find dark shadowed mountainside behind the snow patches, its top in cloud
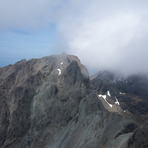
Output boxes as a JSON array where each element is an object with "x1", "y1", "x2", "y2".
[{"x1": 91, "y1": 71, "x2": 148, "y2": 123}]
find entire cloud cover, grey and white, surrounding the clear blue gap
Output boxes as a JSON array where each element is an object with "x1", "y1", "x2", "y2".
[{"x1": 0, "y1": 0, "x2": 148, "y2": 74}]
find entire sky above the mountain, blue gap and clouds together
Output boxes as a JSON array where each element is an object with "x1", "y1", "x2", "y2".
[{"x1": 0, "y1": 0, "x2": 148, "y2": 75}]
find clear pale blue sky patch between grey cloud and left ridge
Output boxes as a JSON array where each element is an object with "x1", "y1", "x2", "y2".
[{"x1": 0, "y1": 25, "x2": 62, "y2": 66}]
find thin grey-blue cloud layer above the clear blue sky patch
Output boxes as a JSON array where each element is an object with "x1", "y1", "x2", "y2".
[{"x1": 0, "y1": 0, "x2": 61, "y2": 31}]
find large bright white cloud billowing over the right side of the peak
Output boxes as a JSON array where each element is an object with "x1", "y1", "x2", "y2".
[{"x1": 56, "y1": 0, "x2": 148, "y2": 74}]
